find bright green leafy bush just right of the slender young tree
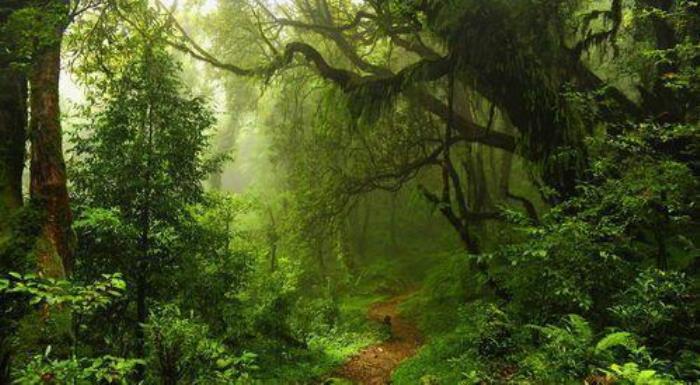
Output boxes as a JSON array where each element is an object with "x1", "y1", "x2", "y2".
[{"x1": 171, "y1": 193, "x2": 259, "y2": 340}]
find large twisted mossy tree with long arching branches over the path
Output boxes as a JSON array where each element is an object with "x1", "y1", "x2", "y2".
[{"x1": 138, "y1": 1, "x2": 592, "y2": 260}]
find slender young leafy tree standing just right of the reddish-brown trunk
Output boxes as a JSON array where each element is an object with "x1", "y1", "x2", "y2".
[{"x1": 74, "y1": 42, "x2": 217, "y2": 364}]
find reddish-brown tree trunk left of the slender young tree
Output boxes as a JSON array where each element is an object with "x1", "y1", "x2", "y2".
[{"x1": 29, "y1": 1, "x2": 74, "y2": 277}]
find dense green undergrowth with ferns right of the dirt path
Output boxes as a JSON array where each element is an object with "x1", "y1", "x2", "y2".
[{"x1": 394, "y1": 97, "x2": 697, "y2": 384}]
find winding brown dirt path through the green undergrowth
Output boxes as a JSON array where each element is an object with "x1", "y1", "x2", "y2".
[{"x1": 337, "y1": 293, "x2": 422, "y2": 385}]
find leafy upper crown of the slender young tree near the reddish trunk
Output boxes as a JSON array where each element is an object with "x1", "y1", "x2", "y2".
[{"x1": 74, "y1": 46, "x2": 216, "y2": 218}]
